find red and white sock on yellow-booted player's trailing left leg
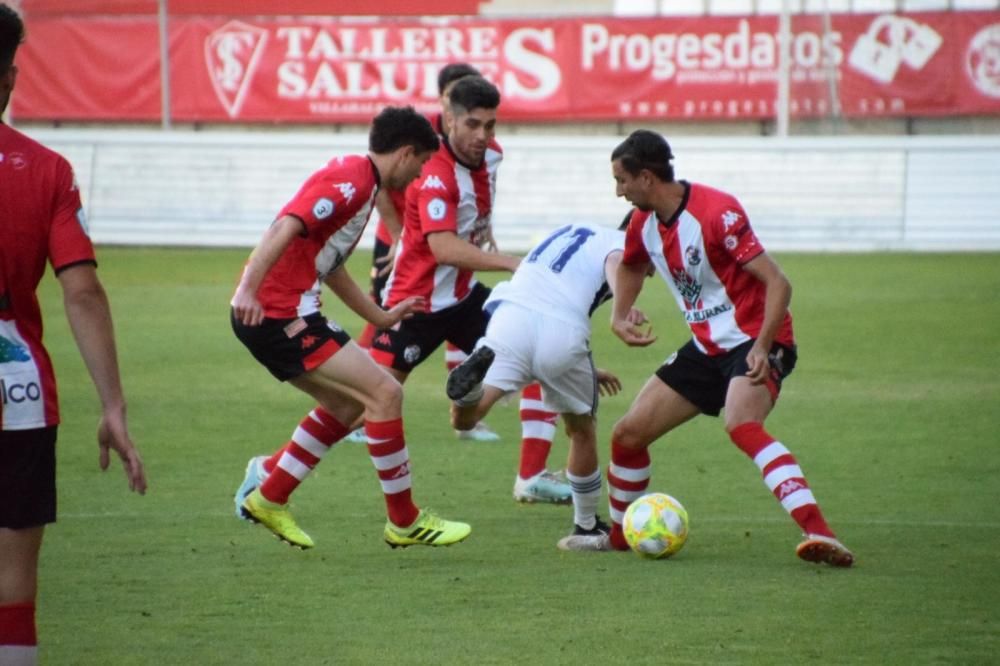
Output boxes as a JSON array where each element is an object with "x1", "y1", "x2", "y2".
[{"x1": 260, "y1": 406, "x2": 350, "y2": 504}]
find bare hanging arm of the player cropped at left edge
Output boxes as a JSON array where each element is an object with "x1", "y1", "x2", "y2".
[{"x1": 58, "y1": 264, "x2": 146, "y2": 494}]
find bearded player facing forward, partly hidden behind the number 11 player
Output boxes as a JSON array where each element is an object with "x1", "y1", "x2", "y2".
[{"x1": 372, "y1": 77, "x2": 571, "y2": 503}]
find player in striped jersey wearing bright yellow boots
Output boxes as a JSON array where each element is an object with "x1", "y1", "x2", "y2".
[{"x1": 231, "y1": 107, "x2": 470, "y2": 548}]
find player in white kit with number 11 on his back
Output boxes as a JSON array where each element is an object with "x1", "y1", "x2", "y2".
[{"x1": 447, "y1": 218, "x2": 645, "y2": 548}]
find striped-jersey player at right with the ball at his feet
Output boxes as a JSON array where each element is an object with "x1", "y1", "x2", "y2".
[{"x1": 572, "y1": 130, "x2": 854, "y2": 567}]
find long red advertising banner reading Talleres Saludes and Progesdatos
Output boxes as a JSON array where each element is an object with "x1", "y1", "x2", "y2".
[{"x1": 13, "y1": 11, "x2": 1000, "y2": 123}]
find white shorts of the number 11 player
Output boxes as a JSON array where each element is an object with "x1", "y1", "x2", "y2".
[{"x1": 479, "y1": 302, "x2": 598, "y2": 416}]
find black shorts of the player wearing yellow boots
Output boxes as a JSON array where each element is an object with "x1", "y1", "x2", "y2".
[{"x1": 229, "y1": 310, "x2": 351, "y2": 382}]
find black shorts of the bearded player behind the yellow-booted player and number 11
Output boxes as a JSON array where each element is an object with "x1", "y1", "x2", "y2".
[{"x1": 371, "y1": 283, "x2": 490, "y2": 372}]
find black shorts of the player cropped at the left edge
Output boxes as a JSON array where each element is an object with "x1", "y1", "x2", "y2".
[{"x1": 0, "y1": 426, "x2": 57, "y2": 530}]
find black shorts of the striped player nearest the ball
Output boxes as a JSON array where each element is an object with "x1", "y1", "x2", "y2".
[{"x1": 656, "y1": 340, "x2": 798, "y2": 416}]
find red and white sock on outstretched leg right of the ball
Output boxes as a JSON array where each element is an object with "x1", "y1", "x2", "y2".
[{"x1": 729, "y1": 421, "x2": 833, "y2": 538}]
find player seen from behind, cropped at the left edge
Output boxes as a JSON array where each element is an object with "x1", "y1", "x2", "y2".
[{"x1": 0, "y1": 4, "x2": 146, "y2": 664}]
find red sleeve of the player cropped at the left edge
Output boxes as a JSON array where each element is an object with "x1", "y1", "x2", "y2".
[{"x1": 49, "y1": 157, "x2": 94, "y2": 273}]
